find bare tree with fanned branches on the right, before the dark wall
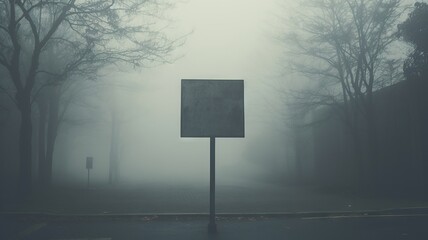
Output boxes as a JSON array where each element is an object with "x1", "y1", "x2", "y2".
[{"x1": 283, "y1": 0, "x2": 402, "y2": 183}]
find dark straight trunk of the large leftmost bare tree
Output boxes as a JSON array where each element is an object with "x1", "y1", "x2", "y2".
[{"x1": 18, "y1": 92, "x2": 32, "y2": 201}]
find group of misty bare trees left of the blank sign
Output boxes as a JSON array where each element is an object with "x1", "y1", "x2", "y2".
[{"x1": 0, "y1": 1, "x2": 181, "y2": 201}]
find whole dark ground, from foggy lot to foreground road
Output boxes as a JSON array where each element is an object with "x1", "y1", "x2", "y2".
[{"x1": 0, "y1": 183, "x2": 428, "y2": 240}]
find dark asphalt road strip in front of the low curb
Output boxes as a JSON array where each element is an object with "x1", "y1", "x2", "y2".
[{"x1": 0, "y1": 214, "x2": 428, "y2": 240}]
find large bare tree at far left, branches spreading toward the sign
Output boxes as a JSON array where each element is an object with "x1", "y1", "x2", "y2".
[{"x1": 0, "y1": 0, "x2": 182, "y2": 199}]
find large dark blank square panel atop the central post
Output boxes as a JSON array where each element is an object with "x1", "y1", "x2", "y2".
[{"x1": 181, "y1": 79, "x2": 245, "y2": 137}]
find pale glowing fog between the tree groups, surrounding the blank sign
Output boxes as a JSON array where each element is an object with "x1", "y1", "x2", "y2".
[{"x1": 53, "y1": 0, "x2": 287, "y2": 187}]
